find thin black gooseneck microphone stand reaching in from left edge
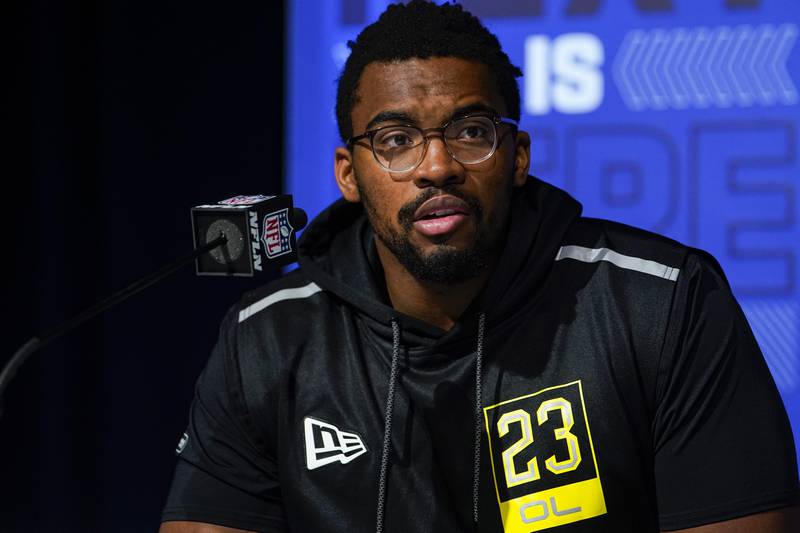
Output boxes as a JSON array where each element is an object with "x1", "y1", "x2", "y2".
[{"x1": 0, "y1": 233, "x2": 228, "y2": 419}]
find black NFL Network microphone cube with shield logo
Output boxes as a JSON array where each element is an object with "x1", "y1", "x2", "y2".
[{"x1": 192, "y1": 195, "x2": 297, "y2": 277}]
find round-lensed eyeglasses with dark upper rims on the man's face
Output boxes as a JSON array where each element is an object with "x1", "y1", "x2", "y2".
[{"x1": 347, "y1": 115, "x2": 517, "y2": 172}]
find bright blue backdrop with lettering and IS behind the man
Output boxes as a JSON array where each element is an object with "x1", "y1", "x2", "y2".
[{"x1": 285, "y1": 0, "x2": 800, "y2": 466}]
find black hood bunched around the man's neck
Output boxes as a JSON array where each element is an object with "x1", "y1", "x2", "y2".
[{"x1": 298, "y1": 177, "x2": 581, "y2": 346}]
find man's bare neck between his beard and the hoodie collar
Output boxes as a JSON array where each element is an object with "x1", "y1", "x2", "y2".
[{"x1": 376, "y1": 239, "x2": 492, "y2": 330}]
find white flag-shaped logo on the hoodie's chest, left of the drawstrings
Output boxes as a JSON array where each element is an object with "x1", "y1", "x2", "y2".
[{"x1": 303, "y1": 416, "x2": 367, "y2": 470}]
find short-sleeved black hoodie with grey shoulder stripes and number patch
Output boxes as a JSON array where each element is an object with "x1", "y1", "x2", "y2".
[{"x1": 163, "y1": 178, "x2": 797, "y2": 533}]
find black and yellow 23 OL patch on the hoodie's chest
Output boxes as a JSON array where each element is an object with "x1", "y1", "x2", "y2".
[{"x1": 483, "y1": 381, "x2": 606, "y2": 533}]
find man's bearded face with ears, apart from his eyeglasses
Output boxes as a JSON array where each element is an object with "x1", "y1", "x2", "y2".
[{"x1": 336, "y1": 57, "x2": 529, "y2": 284}]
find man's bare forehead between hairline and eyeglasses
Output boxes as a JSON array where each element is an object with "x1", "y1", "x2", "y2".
[{"x1": 352, "y1": 57, "x2": 505, "y2": 128}]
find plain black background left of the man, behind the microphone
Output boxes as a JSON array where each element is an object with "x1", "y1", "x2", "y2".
[{"x1": 0, "y1": 0, "x2": 284, "y2": 533}]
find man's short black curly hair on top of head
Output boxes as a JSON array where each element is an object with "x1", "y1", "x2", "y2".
[{"x1": 336, "y1": 0, "x2": 522, "y2": 141}]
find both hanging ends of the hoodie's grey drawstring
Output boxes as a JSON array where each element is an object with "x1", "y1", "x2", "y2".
[{"x1": 375, "y1": 313, "x2": 486, "y2": 533}]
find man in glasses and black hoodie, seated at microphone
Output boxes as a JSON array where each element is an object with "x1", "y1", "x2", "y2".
[{"x1": 162, "y1": 1, "x2": 798, "y2": 533}]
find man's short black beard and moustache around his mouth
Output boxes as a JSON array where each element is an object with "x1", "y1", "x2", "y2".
[{"x1": 358, "y1": 185, "x2": 501, "y2": 285}]
